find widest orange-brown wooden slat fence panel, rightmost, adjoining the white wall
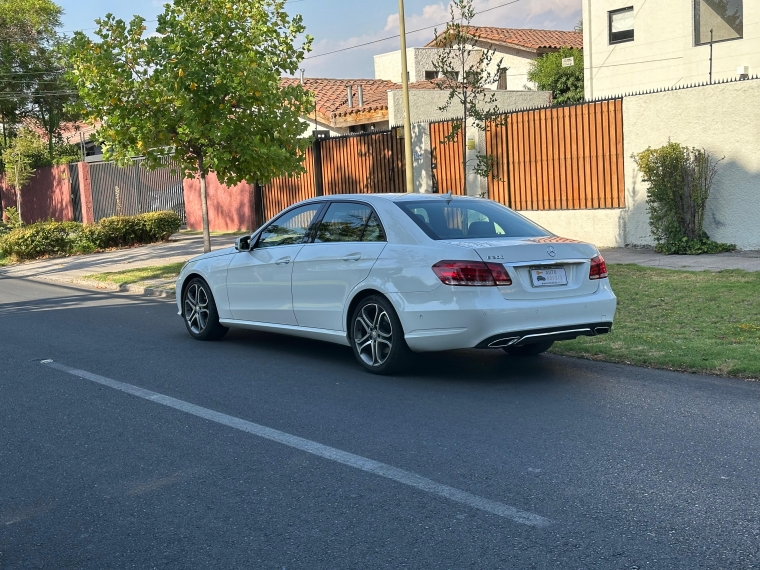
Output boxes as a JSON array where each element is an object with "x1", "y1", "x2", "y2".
[{"x1": 486, "y1": 99, "x2": 625, "y2": 210}]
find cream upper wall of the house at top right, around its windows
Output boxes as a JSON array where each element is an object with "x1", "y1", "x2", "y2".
[{"x1": 582, "y1": 0, "x2": 760, "y2": 99}]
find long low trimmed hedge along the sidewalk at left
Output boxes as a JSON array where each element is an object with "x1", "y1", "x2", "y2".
[{"x1": 0, "y1": 211, "x2": 182, "y2": 260}]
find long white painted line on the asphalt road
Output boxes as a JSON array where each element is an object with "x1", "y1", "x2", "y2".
[{"x1": 41, "y1": 360, "x2": 552, "y2": 527}]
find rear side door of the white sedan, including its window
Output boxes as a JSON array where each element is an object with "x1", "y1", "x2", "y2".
[{"x1": 293, "y1": 201, "x2": 386, "y2": 331}]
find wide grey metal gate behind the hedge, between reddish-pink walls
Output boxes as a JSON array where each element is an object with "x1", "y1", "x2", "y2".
[{"x1": 90, "y1": 158, "x2": 185, "y2": 225}]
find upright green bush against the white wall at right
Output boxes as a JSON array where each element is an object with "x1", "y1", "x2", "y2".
[{"x1": 633, "y1": 142, "x2": 736, "y2": 255}]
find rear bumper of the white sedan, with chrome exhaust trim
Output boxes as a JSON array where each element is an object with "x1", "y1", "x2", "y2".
[{"x1": 388, "y1": 279, "x2": 617, "y2": 352}]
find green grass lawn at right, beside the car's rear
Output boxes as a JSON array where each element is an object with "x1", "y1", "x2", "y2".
[{"x1": 552, "y1": 265, "x2": 760, "y2": 379}]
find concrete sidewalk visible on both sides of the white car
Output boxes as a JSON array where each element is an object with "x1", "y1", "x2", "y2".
[{"x1": 0, "y1": 234, "x2": 760, "y2": 297}]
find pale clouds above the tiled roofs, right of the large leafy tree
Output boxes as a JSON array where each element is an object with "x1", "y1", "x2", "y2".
[{"x1": 304, "y1": 0, "x2": 581, "y2": 78}]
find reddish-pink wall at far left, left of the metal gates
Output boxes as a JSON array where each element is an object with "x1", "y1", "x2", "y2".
[{"x1": 0, "y1": 165, "x2": 74, "y2": 224}]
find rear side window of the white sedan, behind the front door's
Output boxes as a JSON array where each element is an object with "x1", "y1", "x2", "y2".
[{"x1": 314, "y1": 202, "x2": 385, "y2": 243}]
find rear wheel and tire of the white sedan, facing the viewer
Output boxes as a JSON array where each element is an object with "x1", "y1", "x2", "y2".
[{"x1": 349, "y1": 295, "x2": 411, "y2": 374}]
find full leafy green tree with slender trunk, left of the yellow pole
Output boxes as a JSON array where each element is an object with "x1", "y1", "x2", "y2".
[{"x1": 71, "y1": 0, "x2": 312, "y2": 251}]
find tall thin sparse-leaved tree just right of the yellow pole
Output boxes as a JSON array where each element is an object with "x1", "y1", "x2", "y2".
[{"x1": 433, "y1": 0, "x2": 506, "y2": 195}]
